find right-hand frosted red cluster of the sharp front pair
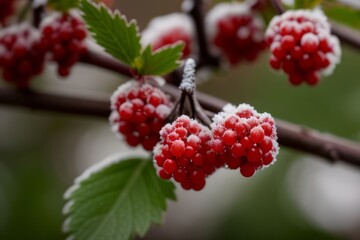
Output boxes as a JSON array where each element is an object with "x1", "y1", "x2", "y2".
[{"x1": 211, "y1": 104, "x2": 278, "y2": 177}]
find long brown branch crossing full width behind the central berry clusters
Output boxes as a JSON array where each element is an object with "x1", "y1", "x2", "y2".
[{"x1": 0, "y1": 85, "x2": 360, "y2": 167}]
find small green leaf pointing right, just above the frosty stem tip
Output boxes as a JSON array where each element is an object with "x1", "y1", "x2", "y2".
[{"x1": 137, "y1": 43, "x2": 184, "y2": 75}]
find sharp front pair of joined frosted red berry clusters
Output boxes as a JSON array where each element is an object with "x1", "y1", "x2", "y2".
[{"x1": 154, "y1": 104, "x2": 279, "y2": 191}]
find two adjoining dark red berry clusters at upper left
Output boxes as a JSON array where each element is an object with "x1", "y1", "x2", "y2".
[{"x1": 0, "y1": 11, "x2": 87, "y2": 87}]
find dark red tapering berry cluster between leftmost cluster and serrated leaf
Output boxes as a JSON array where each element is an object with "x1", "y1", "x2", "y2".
[{"x1": 41, "y1": 14, "x2": 87, "y2": 77}]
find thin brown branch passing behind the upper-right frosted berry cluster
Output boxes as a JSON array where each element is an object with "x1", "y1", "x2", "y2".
[{"x1": 271, "y1": 0, "x2": 360, "y2": 50}]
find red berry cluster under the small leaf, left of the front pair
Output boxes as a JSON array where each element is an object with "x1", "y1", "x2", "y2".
[{"x1": 110, "y1": 81, "x2": 172, "y2": 151}]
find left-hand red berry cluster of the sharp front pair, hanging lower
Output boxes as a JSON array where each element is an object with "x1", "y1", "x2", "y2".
[{"x1": 154, "y1": 115, "x2": 217, "y2": 191}]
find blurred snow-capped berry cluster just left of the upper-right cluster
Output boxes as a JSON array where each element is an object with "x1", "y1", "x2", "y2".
[{"x1": 206, "y1": 2, "x2": 266, "y2": 65}]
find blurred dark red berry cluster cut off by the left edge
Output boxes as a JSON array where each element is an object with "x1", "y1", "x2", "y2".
[{"x1": 0, "y1": 24, "x2": 45, "y2": 87}]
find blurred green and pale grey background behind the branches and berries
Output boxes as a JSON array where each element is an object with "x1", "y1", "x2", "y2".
[{"x1": 0, "y1": 0, "x2": 360, "y2": 240}]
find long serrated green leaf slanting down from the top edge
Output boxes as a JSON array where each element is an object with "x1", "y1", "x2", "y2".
[{"x1": 80, "y1": 0, "x2": 141, "y2": 68}]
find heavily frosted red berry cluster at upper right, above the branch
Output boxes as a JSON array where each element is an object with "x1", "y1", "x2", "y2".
[{"x1": 266, "y1": 10, "x2": 341, "y2": 85}]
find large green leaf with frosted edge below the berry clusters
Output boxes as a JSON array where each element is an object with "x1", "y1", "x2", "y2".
[{"x1": 64, "y1": 156, "x2": 176, "y2": 240}]
